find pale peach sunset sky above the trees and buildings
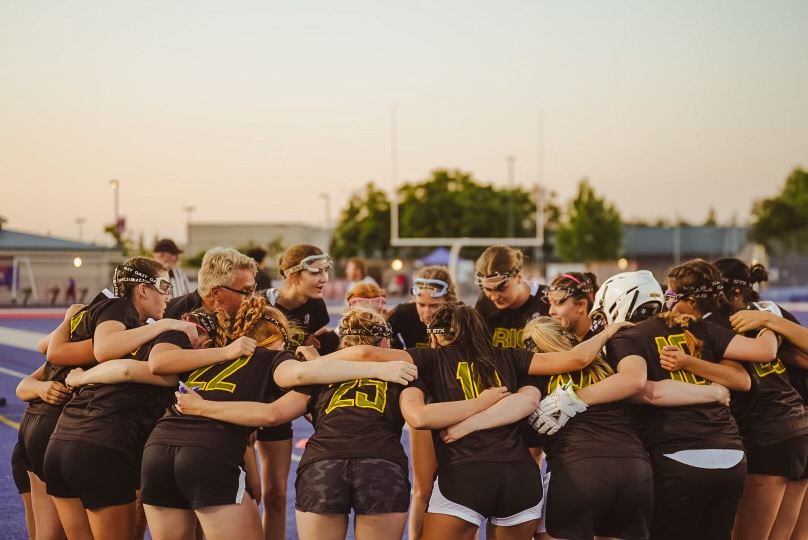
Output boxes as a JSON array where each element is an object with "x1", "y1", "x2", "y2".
[{"x1": 0, "y1": 0, "x2": 808, "y2": 243}]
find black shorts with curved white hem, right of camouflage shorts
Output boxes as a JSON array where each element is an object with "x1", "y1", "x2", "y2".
[{"x1": 427, "y1": 462, "x2": 543, "y2": 527}]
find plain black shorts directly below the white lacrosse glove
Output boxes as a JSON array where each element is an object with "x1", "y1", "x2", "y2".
[{"x1": 546, "y1": 457, "x2": 654, "y2": 540}]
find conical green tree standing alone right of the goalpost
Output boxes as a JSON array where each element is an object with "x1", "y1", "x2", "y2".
[{"x1": 556, "y1": 178, "x2": 623, "y2": 262}]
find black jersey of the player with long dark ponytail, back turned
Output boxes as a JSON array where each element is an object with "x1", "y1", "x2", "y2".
[{"x1": 407, "y1": 346, "x2": 536, "y2": 473}]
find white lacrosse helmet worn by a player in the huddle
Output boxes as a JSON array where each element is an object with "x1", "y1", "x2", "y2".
[{"x1": 589, "y1": 270, "x2": 665, "y2": 324}]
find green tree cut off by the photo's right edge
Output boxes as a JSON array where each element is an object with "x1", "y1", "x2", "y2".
[{"x1": 749, "y1": 168, "x2": 808, "y2": 253}]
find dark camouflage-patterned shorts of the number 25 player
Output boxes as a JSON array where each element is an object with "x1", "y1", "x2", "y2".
[{"x1": 295, "y1": 458, "x2": 410, "y2": 516}]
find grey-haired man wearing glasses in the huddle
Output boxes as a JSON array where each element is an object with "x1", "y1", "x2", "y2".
[{"x1": 165, "y1": 247, "x2": 258, "y2": 319}]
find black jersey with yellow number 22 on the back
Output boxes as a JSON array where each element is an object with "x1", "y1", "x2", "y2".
[{"x1": 146, "y1": 348, "x2": 295, "y2": 463}]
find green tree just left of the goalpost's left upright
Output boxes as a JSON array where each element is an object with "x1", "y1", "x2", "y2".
[{"x1": 329, "y1": 182, "x2": 390, "y2": 259}]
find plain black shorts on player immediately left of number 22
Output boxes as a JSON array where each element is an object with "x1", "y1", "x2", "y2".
[{"x1": 45, "y1": 439, "x2": 138, "y2": 510}]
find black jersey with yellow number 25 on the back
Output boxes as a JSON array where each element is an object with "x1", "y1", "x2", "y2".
[{"x1": 295, "y1": 379, "x2": 407, "y2": 469}]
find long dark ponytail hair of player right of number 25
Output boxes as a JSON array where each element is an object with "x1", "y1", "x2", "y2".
[{"x1": 429, "y1": 302, "x2": 501, "y2": 391}]
